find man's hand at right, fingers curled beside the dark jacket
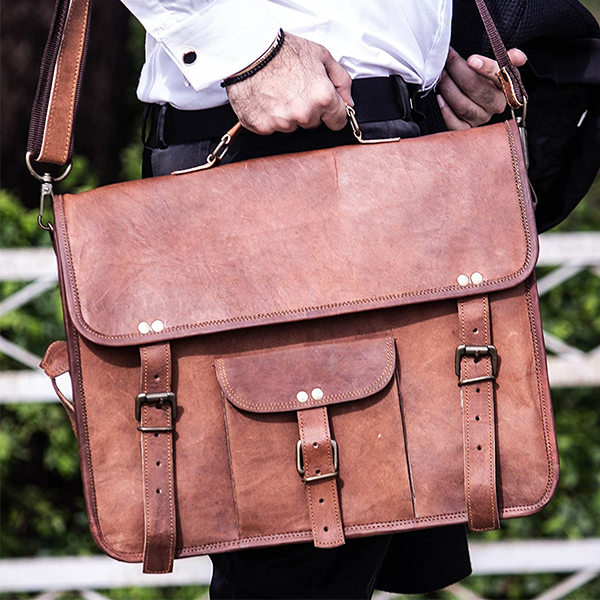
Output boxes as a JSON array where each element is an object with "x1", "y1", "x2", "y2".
[{"x1": 437, "y1": 48, "x2": 527, "y2": 130}]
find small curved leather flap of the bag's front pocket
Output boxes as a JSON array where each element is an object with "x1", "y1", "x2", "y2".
[{"x1": 215, "y1": 337, "x2": 396, "y2": 413}]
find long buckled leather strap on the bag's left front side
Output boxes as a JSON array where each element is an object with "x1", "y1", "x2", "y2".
[{"x1": 136, "y1": 342, "x2": 176, "y2": 573}]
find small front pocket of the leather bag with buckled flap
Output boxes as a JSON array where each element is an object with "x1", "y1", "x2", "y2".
[{"x1": 215, "y1": 337, "x2": 414, "y2": 547}]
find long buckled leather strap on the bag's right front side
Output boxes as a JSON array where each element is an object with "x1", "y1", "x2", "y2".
[{"x1": 457, "y1": 296, "x2": 500, "y2": 531}]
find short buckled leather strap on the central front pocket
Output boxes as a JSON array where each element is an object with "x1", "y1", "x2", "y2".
[{"x1": 297, "y1": 406, "x2": 345, "y2": 548}]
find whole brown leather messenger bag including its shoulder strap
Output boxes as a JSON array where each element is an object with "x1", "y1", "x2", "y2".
[{"x1": 28, "y1": 0, "x2": 558, "y2": 573}]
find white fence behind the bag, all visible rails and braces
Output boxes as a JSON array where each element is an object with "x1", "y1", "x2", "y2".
[{"x1": 0, "y1": 232, "x2": 600, "y2": 600}]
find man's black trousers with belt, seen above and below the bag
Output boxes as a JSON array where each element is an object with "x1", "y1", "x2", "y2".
[{"x1": 143, "y1": 77, "x2": 471, "y2": 600}]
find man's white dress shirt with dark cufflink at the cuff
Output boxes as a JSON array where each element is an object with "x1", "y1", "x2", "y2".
[{"x1": 122, "y1": 0, "x2": 452, "y2": 110}]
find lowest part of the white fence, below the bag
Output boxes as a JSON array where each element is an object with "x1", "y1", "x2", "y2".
[{"x1": 0, "y1": 539, "x2": 600, "y2": 600}]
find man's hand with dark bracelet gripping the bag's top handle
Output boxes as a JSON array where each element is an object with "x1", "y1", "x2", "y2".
[{"x1": 227, "y1": 33, "x2": 354, "y2": 135}]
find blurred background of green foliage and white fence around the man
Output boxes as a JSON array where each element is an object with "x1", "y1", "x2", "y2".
[{"x1": 0, "y1": 0, "x2": 600, "y2": 600}]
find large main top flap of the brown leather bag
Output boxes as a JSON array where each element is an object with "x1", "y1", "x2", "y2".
[{"x1": 55, "y1": 122, "x2": 538, "y2": 346}]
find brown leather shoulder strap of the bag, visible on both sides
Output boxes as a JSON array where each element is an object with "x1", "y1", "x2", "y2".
[{"x1": 27, "y1": 0, "x2": 527, "y2": 165}]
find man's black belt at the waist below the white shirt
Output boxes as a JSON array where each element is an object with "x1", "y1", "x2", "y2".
[{"x1": 144, "y1": 75, "x2": 443, "y2": 147}]
